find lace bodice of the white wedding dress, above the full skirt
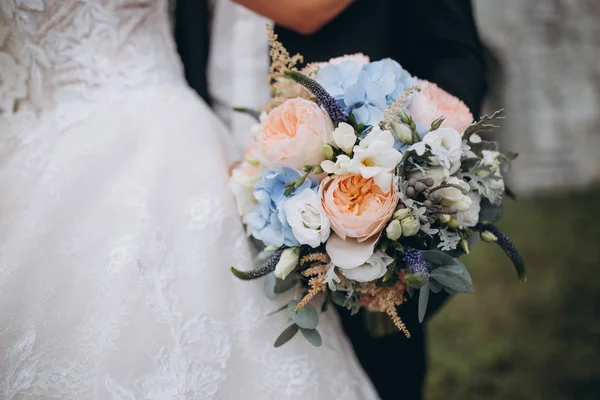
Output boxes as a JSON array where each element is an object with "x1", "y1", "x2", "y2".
[{"x1": 0, "y1": 0, "x2": 182, "y2": 116}]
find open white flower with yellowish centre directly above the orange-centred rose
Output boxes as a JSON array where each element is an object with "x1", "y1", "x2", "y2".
[{"x1": 350, "y1": 126, "x2": 402, "y2": 193}]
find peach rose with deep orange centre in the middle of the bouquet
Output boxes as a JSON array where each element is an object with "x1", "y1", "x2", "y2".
[{"x1": 319, "y1": 175, "x2": 398, "y2": 242}]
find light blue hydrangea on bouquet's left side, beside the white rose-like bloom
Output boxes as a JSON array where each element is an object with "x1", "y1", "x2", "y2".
[{"x1": 245, "y1": 168, "x2": 312, "y2": 247}]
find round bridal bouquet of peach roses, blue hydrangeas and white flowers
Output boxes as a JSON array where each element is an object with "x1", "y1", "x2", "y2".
[{"x1": 230, "y1": 30, "x2": 525, "y2": 346}]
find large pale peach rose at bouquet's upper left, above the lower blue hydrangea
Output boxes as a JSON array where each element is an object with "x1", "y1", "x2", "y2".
[{"x1": 254, "y1": 98, "x2": 333, "y2": 170}]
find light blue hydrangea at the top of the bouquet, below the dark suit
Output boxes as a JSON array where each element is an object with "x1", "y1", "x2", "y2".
[{"x1": 316, "y1": 59, "x2": 417, "y2": 125}]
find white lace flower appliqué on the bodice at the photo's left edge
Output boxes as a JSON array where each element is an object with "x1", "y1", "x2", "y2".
[{"x1": 0, "y1": 51, "x2": 27, "y2": 115}]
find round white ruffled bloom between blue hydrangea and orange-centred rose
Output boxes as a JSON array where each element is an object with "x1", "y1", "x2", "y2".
[{"x1": 283, "y1": 189, "x2": 331, "y2": 248}]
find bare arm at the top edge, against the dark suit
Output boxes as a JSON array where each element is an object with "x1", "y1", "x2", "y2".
[{"x1": 233, "y1": 0, "x2": 354, "y2": 35}]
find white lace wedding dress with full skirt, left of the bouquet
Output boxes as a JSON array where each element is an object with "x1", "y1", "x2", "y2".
[{"x1": 0, "y1": 0, "x2": 376, "y2": 400}]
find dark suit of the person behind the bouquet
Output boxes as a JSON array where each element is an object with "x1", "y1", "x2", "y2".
[{"x1": 177, "y1": 0, "x2": 487, "y2": 400}]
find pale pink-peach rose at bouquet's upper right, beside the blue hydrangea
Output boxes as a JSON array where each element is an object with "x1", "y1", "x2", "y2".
[{"x1": 408, "y1": 79, "x2": 473, "y2": 134}]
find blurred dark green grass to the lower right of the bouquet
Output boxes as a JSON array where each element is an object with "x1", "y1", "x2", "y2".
[{"x1": 426, "y1": 189, "x2": 600, "y2": 400}]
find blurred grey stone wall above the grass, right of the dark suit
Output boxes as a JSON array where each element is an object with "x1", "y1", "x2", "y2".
[{"x1": 474, "y1": 0, "x2": 600, "y2": 193}]
